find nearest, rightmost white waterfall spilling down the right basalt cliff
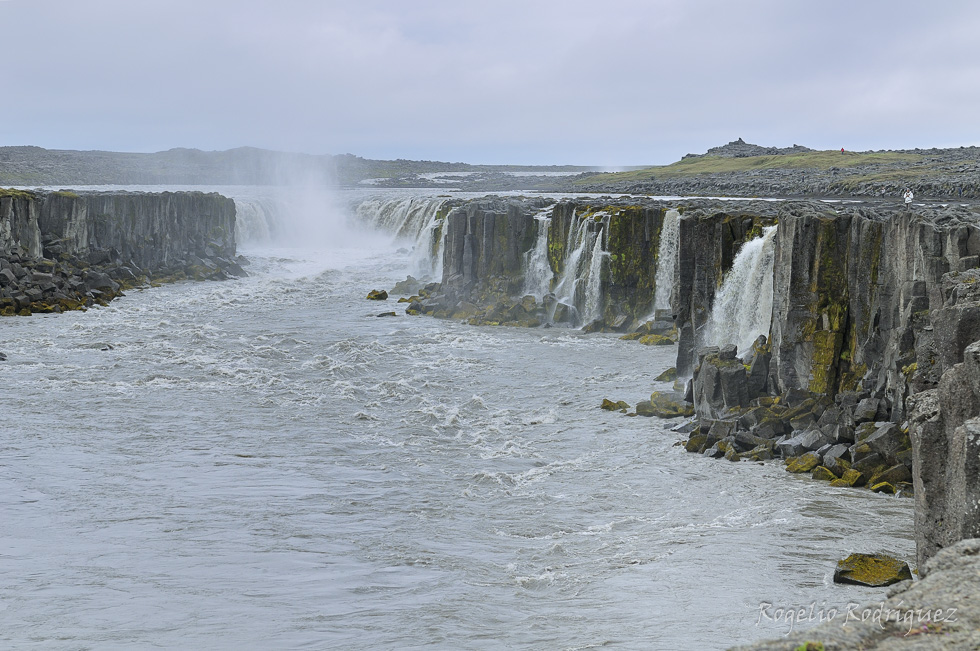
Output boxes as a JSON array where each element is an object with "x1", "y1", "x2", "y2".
[{"x1": 707, "y1": 226, "x2": 776, "y2": 356}]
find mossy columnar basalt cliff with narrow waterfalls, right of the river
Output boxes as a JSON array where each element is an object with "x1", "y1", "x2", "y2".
[{"x1": 394, "y1": 198, "x2": 980, "y2": 562}]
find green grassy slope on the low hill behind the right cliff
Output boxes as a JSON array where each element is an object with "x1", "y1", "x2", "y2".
[{"x1": 578, "y1": 150, "x2": 922, "y2": 184}]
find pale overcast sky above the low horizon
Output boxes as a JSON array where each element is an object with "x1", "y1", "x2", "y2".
[{"x1": 0, "y1": 0, "x2": 980, "y2": 166}]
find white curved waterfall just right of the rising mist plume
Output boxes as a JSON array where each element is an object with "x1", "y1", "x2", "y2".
[{"x1": 354, "y1": 197, "x2": 447, "y2": 280}]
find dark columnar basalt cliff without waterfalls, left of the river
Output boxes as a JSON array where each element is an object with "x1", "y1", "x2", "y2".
[{"x1": 0, "y1": 190, "x2": 244, "y2": 315}]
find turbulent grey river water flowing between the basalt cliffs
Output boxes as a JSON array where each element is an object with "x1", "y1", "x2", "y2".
[{"x1": 0, "y1": 186, "x2": 913, "y2": 649}]
